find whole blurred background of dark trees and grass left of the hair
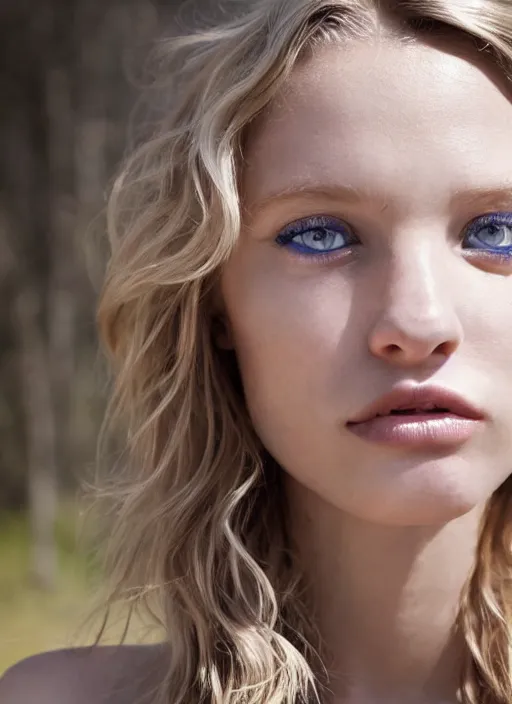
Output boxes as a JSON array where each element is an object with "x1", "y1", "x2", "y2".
[{"x1": 0, "y1": 0, "x2": 214, "y2": 674}]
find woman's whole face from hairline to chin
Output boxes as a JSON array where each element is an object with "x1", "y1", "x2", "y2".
[{"x1": 222, "y1": 35, "x2": 512, "y2": 525}]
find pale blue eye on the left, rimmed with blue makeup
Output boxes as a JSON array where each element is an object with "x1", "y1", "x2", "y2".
[{"x1": 276, "y1": 215, "x2": 358, "y2": 255}]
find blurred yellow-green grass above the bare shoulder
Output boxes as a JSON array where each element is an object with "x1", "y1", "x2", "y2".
[{"x1": 0, "y1": 504, "x2": 162, "y2": 675}]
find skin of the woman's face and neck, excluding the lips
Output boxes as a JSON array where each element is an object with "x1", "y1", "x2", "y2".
[{"x1": 222, "y1": 31, "x2": 512, "y2": 704}]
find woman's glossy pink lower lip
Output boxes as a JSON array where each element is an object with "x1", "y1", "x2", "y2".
[{"x1": 346, "y1": 413, "x2": 481, "y2": 447}]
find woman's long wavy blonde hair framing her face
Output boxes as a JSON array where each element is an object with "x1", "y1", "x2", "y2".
[{"x1": 91, "y1": 0, "x2": 512, "y2": 704}]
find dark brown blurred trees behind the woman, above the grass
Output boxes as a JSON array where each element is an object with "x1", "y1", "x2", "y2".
[{"x1": 0, "y1": 0, "x2": 171, "y2": 588}]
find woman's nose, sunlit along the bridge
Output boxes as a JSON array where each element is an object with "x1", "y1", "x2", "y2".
[{"x1": 368, "y1": 246, "x2": 462, "y2": 367}]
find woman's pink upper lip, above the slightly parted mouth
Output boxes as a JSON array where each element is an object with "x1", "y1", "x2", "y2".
[{"x1": 348, "y1": 386, "x2": 484, "y2": 423}]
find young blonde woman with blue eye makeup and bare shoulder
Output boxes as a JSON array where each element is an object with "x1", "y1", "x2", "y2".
[{"x1": 0, "y1": 0, "x2": 512, "y2": 704}]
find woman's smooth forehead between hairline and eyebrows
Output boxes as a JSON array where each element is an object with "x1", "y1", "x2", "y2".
[{"x1": 243, "y1": 42, "x2": 512, "y2": 212}]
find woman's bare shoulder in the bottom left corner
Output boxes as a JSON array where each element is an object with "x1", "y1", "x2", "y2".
[{"x1": 0, "y1": 644, "x2": 167, "y2": 704}]
